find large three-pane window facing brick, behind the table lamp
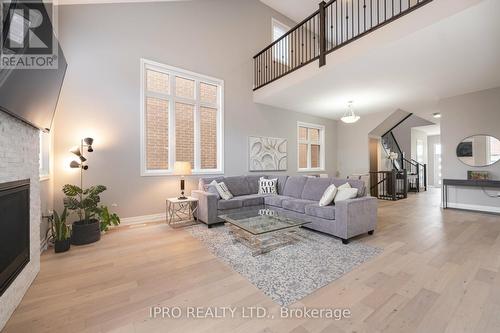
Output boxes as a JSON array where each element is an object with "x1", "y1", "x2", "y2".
[{"x1": 141, "y1": 59, "x2": 224, "y2": 176}]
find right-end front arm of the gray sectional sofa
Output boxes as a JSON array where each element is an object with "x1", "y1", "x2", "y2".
[{"x1": 335, "y1": 196, "x2": 378, "y2": 239}]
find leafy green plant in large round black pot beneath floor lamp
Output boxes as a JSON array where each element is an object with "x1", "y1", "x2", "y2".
[{"x1": 63, "y1": 184, "x2": 106, "y2": 245}]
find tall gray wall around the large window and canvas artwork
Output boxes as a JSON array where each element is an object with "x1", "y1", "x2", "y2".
[{"x1": 54, "y1": 0, "x2": 337, "y2": 217}]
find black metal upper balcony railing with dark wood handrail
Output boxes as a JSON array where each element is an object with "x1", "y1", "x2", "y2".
[{"x1": 254, "y1": 0, "x2": 432, "y2": 90}]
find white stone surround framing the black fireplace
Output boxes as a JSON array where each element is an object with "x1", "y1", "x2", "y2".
[{"x1": 0, "y1": 111, "x2": 41, "y2": 330}]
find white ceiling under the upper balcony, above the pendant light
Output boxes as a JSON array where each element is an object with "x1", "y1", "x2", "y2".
[{"x1": 254, "y1": 0, "x2": 500, "y2": 120}]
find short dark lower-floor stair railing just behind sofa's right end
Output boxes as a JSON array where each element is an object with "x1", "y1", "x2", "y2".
[{"x1": 370, "y1": 170, "x2": 408, "y2": 201}]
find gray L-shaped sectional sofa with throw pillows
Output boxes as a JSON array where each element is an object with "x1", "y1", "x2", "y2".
[{"x1": 191, "y1": 175, "x2": 377, "y2": 243}]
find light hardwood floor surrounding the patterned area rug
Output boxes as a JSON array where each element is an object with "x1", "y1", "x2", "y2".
[{"x1": 5, "y1": 189, "x2": 500, "y2": 333}]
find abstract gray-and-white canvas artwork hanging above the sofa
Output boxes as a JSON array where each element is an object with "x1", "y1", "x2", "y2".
[{"x1": 248, "y1": 136, "x2": 287, "y2": 171}]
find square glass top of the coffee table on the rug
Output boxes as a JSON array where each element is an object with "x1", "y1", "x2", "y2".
[{"x1": 219, "y1": 206, "x2": 310, "y2": 235}]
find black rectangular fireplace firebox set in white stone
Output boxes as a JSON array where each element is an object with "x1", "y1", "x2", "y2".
[{"x1": 0, "y1": 179, "x2": 30, "y2": 296}]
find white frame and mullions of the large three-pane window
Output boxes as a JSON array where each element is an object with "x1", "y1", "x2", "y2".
[{"x1": 140, "y1": 59, "x2": 224, "y2": 176}]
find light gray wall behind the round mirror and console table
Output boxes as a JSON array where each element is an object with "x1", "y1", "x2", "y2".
[{"x1": 439, "y1": 88, "x2": 500, "y2": 212}]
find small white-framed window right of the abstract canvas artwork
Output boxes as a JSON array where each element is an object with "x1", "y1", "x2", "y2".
[{"x1": 297, "y1": 122, "x2": 325, "y2": 171}]
